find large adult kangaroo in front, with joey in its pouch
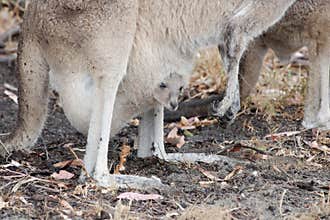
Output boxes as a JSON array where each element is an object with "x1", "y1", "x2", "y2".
[{"x1": 1, "y1": 0, "x2": 295, "y2": 188}]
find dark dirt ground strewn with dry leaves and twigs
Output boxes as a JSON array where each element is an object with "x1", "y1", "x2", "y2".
[{"x1": 0, "y1": 55, "x2": 330, "y2": 219}]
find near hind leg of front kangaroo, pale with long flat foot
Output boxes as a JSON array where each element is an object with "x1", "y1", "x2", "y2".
[{"x1": 79, "y1": 1, "x2": 163, "y2": 188}]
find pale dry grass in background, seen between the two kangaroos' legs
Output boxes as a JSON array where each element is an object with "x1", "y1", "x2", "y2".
[{"x1": 190, "y1": 48, "x2": 308, "y2": 120}]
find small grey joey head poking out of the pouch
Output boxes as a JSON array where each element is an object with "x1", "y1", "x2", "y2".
[{"x1": 153, "y1": 73, "x2": 186, "y2": 111}]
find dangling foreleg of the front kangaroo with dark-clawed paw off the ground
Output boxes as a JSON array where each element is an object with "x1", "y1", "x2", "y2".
[{"x1": 213, "y1": 0, "x2": 295, "y2": 122}]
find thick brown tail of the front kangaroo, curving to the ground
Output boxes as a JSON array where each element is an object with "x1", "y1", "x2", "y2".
[{"x1": 0, "y1": 36, "x2": 49, "y2": 156}]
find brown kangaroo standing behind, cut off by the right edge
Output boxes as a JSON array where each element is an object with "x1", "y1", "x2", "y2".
[{"x1": 240, "y1": 0, "x2": 330, "y2": 129}]
